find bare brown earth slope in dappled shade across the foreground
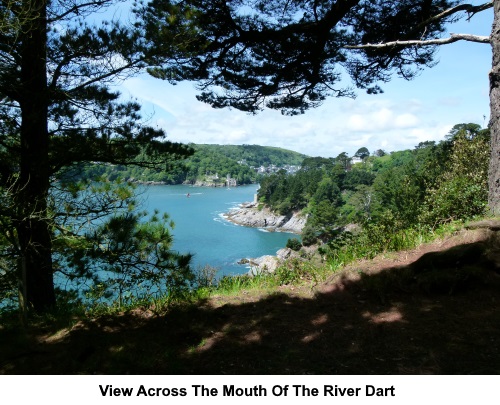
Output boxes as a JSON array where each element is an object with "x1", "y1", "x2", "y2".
[{"x1": 0, "y1": 223, "x2": 500, "y2": 374}]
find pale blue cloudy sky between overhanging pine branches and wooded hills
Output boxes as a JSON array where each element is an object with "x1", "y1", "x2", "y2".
[{"x1": 120, "y1": 1, "x2": 493, "y2": 157}]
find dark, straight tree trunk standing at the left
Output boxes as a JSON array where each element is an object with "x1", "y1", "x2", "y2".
[{"x1": 16, "y1": 0, "x2": 55, "y2": 311}]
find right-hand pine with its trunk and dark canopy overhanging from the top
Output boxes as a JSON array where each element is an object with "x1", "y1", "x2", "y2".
[{"x1": 144, "y1": 0, "x2": 500, "y2": 213}]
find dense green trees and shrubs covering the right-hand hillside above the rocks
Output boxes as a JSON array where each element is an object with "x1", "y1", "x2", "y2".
[{"x1": 254, "y1": 124, "x2": 489, "y2": 261}]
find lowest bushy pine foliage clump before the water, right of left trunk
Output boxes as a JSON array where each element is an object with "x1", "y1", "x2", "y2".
[{"x1": 82, "y1": 213, "x2": 194, "y2": 302}]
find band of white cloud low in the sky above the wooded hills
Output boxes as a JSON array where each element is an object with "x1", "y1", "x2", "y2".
[{"x1": 123, "y1": 49, "x2": 488, "y2": 156}]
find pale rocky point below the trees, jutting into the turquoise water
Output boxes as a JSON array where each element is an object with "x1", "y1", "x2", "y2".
[{"x1": 225, "y1": 203, "x2": 307, "y2": 233}]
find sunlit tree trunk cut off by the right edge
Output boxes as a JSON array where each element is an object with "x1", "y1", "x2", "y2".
[{"x1": 488, "y1": 0, "x2": 500, "y2": 215}]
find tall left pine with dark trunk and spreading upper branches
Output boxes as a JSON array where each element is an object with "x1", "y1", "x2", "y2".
[{"x1": 0, "y1": 0, "x2": 191, "y2": 310}]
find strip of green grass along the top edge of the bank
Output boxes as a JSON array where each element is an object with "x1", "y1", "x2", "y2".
[{"x1": 0, "y1": 222, "x2": 463, "y2": 326}]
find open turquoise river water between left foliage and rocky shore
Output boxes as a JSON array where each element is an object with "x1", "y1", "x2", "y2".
[{"x1": 139, "y1": 185, "x2": 297, "y2": 275}]
